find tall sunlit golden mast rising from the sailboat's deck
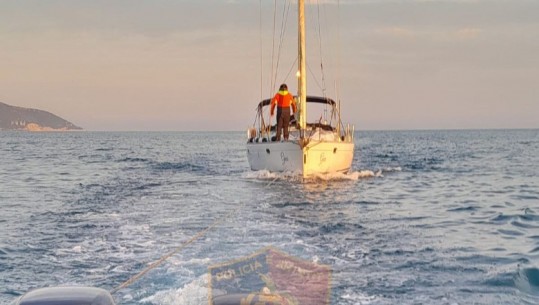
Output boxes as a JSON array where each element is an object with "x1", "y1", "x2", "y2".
[{"x1": 298, "y1": 0, "x2": 307, "y2": 140}]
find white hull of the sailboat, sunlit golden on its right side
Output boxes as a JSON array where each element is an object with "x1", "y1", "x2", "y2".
[{"x1": 247, "y1": 139, "x2": 354, "y2": 177}]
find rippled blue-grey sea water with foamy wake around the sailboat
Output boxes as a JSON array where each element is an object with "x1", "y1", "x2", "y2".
[{"x1": 0, "y1": 130, "x2": 539, "y2": 305}]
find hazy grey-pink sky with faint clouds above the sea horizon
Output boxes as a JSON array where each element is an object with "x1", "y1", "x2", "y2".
[{"x1": 0, "y1": 0, "x2": 539, "y2": 131}]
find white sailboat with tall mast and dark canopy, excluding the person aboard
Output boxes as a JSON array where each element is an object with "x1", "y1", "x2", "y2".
[{"x1": 247, "y1": 0, "x2": 354, "y2": 178}]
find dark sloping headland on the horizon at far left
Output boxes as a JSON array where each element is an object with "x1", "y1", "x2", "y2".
[{"x1": 0, "y1": 102, "x2": 82, "y2": 131}]
